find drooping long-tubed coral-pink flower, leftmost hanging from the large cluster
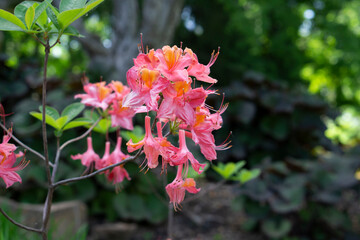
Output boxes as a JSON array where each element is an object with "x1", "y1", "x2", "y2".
[{"x1": 126, "y1": 116, "x2": 160, "y2": 168}]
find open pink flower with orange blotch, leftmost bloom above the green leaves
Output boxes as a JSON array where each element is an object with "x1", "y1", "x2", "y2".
[{"x1": 75, "y1": 82, "x2": 112, "y2": 110}]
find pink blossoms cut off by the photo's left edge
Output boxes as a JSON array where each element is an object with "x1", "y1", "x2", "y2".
[{"x1": 0, "y1": 130, "x2": 28, "y2": 188}]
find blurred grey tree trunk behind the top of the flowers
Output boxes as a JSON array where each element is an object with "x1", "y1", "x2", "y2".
[{"x1": 76, "y1": 0, "x2": 184, "y2": 82}]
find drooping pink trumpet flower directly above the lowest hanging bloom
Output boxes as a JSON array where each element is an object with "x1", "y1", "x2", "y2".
[{"x1": 171, "y1": 130, "x2": 206, "y2": 174}]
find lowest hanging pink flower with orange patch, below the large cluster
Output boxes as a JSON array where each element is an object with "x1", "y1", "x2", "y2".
[{"x1": 166, "y1": 165, "x2": 201, "y2": 210}]
